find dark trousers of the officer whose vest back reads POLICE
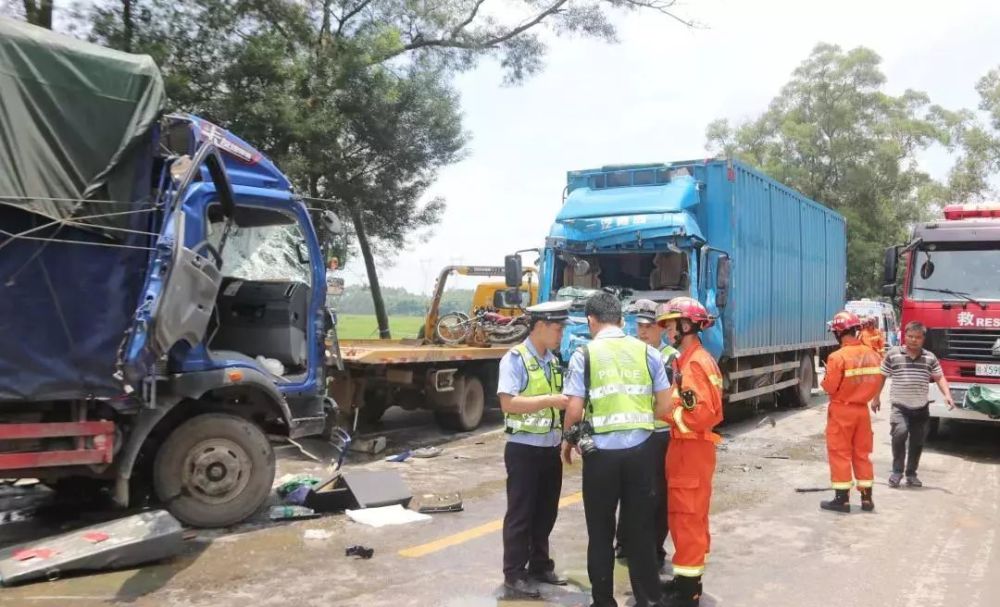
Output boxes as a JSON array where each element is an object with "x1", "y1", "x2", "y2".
[{"x1": 583, "y1": 439, "x2": 662, "y2": 607}]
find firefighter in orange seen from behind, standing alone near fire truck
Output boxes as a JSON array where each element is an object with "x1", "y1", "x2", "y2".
[{"x1": 820, "y1": 312, "x2": 882, "y2": 512}]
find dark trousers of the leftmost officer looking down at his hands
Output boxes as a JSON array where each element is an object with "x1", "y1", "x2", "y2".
[{"x1": 503, "y1": 442, "x2": 562, "y2": 580}]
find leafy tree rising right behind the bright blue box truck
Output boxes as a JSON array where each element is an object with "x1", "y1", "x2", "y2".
[{"x1": 706, "y1": 44, "x2": 956, "y2": 298}]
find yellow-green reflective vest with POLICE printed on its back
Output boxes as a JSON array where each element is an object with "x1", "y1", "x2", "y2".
[{"x1": 584, "y1": 337, "x2": 655, "y2": 434}]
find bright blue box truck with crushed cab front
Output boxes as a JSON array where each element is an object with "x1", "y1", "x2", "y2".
[{"x1": 540, "y1": 159, "x2": 847, "y2": 405}]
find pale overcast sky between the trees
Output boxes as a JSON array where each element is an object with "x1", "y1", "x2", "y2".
[{"x1": 343, "y1": 0, "x2": 1000, "y2": 292}]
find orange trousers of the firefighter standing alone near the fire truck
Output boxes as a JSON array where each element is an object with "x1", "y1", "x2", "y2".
[{"x1": 826, "y1": 402, "x2": 875, "y2": 489}]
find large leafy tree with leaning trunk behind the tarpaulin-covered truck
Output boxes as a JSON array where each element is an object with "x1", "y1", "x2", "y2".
[{"x1": 81, "y1": 0, "x2": 688, "y2": 337}]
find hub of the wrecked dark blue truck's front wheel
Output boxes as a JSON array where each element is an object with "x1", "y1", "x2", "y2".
[{"x1": 184, "y1": 438, "x2": 252, "y2": 503}]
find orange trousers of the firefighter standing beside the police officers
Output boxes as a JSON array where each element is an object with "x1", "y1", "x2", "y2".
[{"x1": 667, "y1": 434, "x2": 715, "y2": 577}]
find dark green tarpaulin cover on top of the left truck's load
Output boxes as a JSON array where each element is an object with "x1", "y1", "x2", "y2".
[{"x1": 0, "y1": 18, "x2": 165, "y2": 236}]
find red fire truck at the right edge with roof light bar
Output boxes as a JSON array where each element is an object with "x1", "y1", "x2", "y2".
[{"x1": 884, "y1": 204, "x2": 1000, "y2": 433}]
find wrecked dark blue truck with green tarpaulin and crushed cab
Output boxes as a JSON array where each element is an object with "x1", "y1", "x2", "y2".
[{"x1": 0, "y1": 19, "x2": 339, "y2": 527}]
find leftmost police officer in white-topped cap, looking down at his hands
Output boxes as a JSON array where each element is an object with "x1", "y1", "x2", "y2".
[{"x1": 497, "y1": 302, "x2": 570, "y2": 598}]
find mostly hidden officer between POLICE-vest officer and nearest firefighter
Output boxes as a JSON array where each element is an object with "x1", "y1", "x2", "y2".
[{"x1": 615, "y1": 299, "x2": 677, "y2": 576}]
